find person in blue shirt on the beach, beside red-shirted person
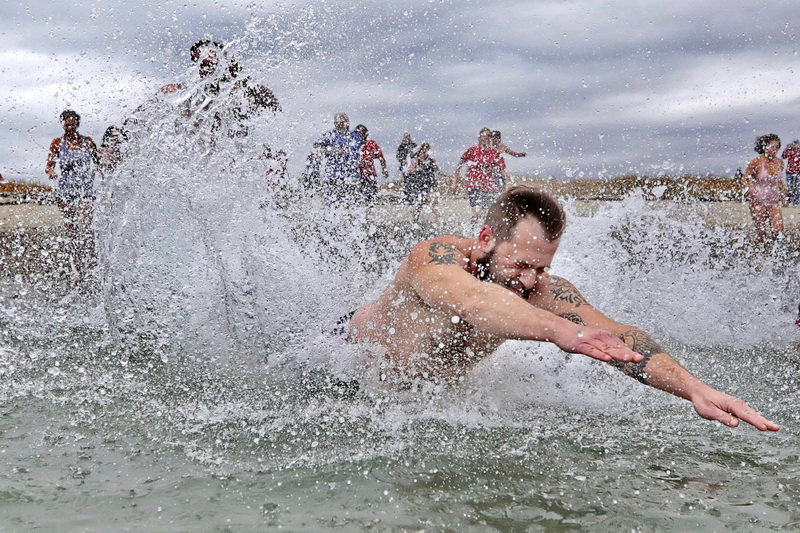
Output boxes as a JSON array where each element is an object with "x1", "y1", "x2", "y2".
[{"x1": 314, "y1": 113, "x2": 364, "y2": 205}]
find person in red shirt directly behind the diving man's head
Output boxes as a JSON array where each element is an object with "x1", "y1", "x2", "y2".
[{"x1": 452, "y1": 128, "x2": 508, "y2": 220}]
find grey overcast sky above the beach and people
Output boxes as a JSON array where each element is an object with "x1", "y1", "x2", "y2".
[{"x1": 0, "y1": 0, "x2": 800, "y2": 180}]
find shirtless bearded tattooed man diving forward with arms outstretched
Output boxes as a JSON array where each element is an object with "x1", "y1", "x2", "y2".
[{"x1": 349, "y1": 186, "x2": 779, "y2": 431}]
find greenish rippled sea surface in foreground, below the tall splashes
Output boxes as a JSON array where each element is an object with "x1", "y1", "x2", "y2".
[{"x1": 0, "y1": 285, "x2": 800, "y2": 531}]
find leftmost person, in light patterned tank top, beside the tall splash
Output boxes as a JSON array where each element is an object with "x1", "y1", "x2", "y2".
[{"x1": 45, "y1": 109, "x2": 99, "y2": 281}]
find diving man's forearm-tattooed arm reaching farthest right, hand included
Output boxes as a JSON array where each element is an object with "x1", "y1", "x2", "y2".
[{"x1": 541, "y1": 277, "x2": 780, "y2": 431}]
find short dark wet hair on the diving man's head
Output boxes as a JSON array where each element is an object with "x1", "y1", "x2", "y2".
[{"x1": 486, "y1": 185, "x2": 567, "y2": 241}]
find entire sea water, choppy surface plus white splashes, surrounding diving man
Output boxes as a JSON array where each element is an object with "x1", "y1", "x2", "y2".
[{"x1": 0, "y1": 52, "x2": 800, "y2": 531}]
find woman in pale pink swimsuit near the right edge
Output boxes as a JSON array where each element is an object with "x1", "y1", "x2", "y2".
[{"x1": 742, "y1": 133, "x2": 786, "y2": 250}]
